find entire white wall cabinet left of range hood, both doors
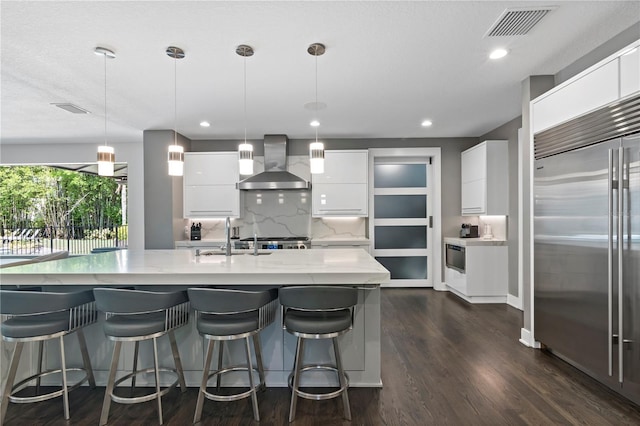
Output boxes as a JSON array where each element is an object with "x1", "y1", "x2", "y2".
[{"x1": 183, "y1": 152, "x2": 241, "y2": 218}]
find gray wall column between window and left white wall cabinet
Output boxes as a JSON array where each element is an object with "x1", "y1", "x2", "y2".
[{"x1": 142, "y1": 130, "x2": 190, "y2": 249}]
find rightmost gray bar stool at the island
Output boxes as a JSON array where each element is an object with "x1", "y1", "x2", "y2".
[{"x1": 280, "y1": 286, "x2": 358, "y2": 422}]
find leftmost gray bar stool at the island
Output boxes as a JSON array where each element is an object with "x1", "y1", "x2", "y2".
[{"x1": 0, "y1": 289, "x2": 98, "y2": 424}]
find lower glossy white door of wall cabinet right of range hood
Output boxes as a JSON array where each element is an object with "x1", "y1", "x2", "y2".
[{"x1": 312, "y1": 183, "x2": 368, "y2": 217}]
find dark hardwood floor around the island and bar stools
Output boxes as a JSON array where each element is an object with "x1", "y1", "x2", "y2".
[{"x1": 5, "y1": 289, "x2": 640, "y2": 426}]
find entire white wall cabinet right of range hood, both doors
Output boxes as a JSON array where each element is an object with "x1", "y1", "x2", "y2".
[{"x1": 311, "y1": 150, "x2": 369, "y2": 217}]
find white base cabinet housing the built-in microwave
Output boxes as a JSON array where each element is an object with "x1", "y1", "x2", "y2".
[{"x1": 445, "y1": 238, "x2": 509, "y2": 303}]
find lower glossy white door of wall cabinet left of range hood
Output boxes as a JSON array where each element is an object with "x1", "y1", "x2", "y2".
[{"x1": 184, "y1": 185, "x2": 240, "y2": 218}]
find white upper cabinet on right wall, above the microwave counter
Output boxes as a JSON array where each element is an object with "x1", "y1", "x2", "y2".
[{"x1": 461, "y1": 140, "x2": 509, "y2": 216}]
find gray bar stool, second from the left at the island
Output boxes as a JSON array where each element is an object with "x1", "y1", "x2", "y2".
[{"x1": 93, "y1": 288, "x2": 189, "y2": 425}]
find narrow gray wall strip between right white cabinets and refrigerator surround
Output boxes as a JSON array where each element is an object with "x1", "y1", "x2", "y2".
[{"x1": 480, "y1": 116, "x2": 522, "y2": 297}]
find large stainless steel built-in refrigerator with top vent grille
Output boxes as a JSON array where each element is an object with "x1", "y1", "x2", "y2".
[{"x1": 533, "y1": 96, "x2": 640, "y2": 404}]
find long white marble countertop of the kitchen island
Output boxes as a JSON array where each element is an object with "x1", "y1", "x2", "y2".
[{"x1": 0, "y1": 248, "x2": 390, "y2": 285}]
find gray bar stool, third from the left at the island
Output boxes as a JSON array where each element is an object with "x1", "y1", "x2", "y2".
[{"x1": 189, "y1": 288, "x2": 278, "y2": 423}]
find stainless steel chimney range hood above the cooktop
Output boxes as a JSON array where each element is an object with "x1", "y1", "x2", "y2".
[{"x1": 236, "y1": 135, "x2": 311, "y2": 191}]
